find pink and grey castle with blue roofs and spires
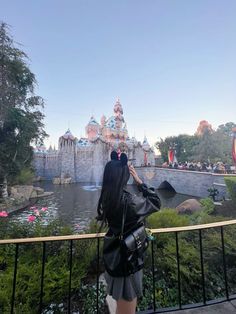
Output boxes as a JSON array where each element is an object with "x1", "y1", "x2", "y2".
[{"x1": 34, "y1": 99, "x2": 155, "y2": 183}]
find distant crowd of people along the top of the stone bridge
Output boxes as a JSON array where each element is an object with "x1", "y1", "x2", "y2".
[{"x1": 162, "y1": 161, "x2": 236, "y2": 173}]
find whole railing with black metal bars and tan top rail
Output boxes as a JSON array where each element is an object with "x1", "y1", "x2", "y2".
[{"x1": 0, "y1": 220, "x2": 236, "y2": 314}]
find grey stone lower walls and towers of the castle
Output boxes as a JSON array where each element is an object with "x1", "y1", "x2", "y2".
[{"x1": 34, "y1": 139, "x2": 155, "y2": 183}]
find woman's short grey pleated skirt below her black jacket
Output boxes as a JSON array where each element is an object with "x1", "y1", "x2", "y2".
[{"x1": 105, "y1": 269, "x2": 143, "y2": 301}]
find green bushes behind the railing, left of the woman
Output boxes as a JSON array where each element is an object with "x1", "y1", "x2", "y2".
[{"x1": 0, "y1": 218, "x2": 96, "y2": 314}]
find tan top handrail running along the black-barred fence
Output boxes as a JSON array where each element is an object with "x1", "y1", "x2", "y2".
[{"x1": 0, "y1": 219, "x2": 236, "y2": 245}]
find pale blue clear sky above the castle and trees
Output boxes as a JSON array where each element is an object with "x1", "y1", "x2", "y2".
[{"x1": 0, "y1": 0, "x2": 236, "y2": 146}]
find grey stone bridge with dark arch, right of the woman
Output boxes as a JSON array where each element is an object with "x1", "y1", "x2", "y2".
[{"x1": 135, "y1": 167, "x2": 236, "y2": 197}]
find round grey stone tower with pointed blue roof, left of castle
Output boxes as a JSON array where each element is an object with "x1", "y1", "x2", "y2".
[{"x1": 58, "y1": 129, "x2": 77, "y2": 182}]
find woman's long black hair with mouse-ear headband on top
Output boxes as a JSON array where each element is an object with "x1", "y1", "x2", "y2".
[{"x1": 97, "y1": 151, "x2": 130, "y2": 221}]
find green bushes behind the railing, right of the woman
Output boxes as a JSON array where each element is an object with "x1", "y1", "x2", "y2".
[{"x1": 143, "y1": 207, "x2": 236, "y2": 310}]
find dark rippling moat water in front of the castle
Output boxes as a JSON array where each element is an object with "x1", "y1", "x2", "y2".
[{"x1": 11, "y1": 182, "x2": 195, "y2": 232}]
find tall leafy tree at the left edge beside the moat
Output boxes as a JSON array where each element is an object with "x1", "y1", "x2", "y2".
[{"x1": 0, "y1": 23, "x2": 47, "y2": 197}]
